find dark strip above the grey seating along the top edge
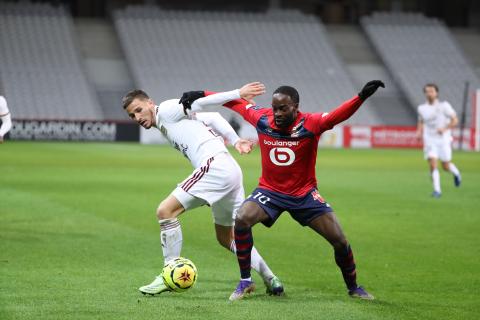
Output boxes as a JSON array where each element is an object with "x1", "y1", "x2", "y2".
[{"x1": 28, "y1": 0, "x2": 480, "y2": 27}]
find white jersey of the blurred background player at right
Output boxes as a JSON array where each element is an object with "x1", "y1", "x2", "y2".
[{"x1": 417, "y1": 100, "x2": 456, "y2": 143}]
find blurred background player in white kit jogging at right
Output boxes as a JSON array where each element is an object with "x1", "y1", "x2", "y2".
[{"x1": 417, "y1": 83, "x2": 462, "y2": 198}]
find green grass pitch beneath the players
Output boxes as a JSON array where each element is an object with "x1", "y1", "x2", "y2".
[{"x1": 0, "y1": 141, "x2": 480, "y2": 320}]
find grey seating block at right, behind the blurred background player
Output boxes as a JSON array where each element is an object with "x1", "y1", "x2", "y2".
[{"x1": 361, "y1": 13, "x2": 480, "y2": 124}]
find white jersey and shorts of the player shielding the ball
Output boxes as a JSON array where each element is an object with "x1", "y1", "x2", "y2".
[{"x1": 155, "y1": 90, "x2": 245, "y2": 226}]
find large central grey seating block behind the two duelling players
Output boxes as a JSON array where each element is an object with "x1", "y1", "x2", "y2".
[{"x1": 113, "y1": 6, "x2": 379, "y2": 124}]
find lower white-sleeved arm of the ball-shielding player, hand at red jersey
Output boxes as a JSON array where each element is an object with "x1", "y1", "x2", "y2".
[{"x1": 194, "y1": 112, "x2": 253, "y2": 154}]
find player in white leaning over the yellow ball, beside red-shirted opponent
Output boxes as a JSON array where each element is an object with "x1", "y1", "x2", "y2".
[{"x1": 123, "y1": 84, "x2": 283, "y2": 295}]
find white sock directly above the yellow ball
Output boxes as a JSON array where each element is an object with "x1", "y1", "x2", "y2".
[{"x1": 158, "y1": 218, "x2": 183, "y2": 264}]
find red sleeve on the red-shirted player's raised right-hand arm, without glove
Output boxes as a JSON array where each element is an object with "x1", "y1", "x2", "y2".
[{"x1": 305, "y1": 96, "x2": 363, "y2": 134}]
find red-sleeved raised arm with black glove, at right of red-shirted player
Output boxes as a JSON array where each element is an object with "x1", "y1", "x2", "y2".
[{"x1": 317, "y1": 80, "x2": 385, "y2": 133}]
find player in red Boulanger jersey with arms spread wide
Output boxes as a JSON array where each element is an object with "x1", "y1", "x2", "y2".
[{"x1": 181, "y1": 80, "x2": 385, "y2": 301}]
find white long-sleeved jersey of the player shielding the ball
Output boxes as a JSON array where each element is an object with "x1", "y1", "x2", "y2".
[{"x1": 155, "y1": 91, "x2": 239, "y2": 168}]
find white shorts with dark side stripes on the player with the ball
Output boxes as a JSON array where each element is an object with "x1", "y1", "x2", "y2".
[{"x1": 172, "y1": 152, "x2": 245, "y2": 226}]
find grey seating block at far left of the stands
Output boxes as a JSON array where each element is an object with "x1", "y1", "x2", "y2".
[{"x1": 0, "y1": 3, "x2": 103, "y2": 120}]
